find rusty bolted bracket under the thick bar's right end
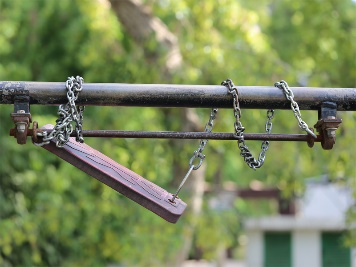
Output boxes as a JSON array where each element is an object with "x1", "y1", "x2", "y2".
[{"x1": 314, "y1": 102, "x2": 342, "y2": 150}]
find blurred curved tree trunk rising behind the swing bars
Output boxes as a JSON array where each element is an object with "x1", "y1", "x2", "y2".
[{"x1": 109, "y1": 0, "x2": 206, "y2": 266}]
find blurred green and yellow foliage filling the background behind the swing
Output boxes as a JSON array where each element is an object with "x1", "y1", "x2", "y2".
[{"x1": 0, "y1": 0, "x2": 356, "y2": 266}]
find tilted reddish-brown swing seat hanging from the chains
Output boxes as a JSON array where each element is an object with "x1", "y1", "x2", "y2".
[{"x1": 41, "y1": 124, "x2": 187, "y2": 223}]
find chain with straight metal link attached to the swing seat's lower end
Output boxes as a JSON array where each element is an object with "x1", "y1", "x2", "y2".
[{"x1": 170, "y1": 108, "x2": 218, "y2": 203}]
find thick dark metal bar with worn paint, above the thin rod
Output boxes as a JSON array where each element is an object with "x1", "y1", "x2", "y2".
[{"x1": 0, "y1": 82, "x2": 356, "y2": 111}]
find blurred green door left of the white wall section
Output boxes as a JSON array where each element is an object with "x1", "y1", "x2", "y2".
[{"x1": 263, "y1": 232, "x2": 292, "y2": 267}]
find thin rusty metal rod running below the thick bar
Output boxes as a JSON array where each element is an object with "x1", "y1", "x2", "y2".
[{"x1": 10, "y1": 129, "x2": 321, "y2": 142}]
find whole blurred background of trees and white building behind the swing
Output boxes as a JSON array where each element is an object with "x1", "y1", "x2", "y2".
[{"x1": 0, "y1": 0, "x2": 356, "y2": 267}]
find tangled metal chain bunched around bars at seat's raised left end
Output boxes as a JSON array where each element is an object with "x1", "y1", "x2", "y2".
[{"x1": 35, "y1": 76, "x2": 85, "y2": 147}]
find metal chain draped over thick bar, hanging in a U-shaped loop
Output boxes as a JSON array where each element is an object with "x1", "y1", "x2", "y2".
[{"x1": 221, "y1": 79, "x2": 274, "y2": 170}]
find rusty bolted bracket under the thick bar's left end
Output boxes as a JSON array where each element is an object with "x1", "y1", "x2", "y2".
[{"x1": 10, "y1": 93, "x2": 32, "y2": 145}]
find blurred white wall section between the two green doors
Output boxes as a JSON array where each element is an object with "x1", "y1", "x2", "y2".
[{"x1": 292, "y1": 230, "x2": 322, "y2": 267}]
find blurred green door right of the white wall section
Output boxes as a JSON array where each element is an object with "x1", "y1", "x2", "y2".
[{"x1": 321, "y1": 232, "x2": 351, "y2": 267}]
